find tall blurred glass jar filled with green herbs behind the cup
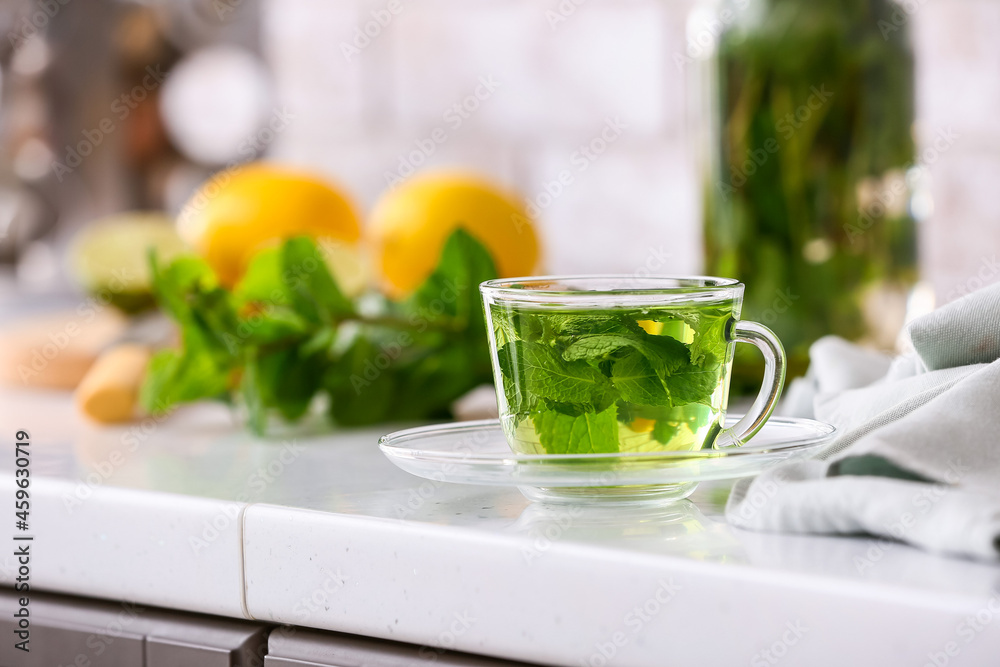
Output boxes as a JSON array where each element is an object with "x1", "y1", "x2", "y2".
[{"x1": 689, "y1": 0, "x2": 920, "y2": 389}]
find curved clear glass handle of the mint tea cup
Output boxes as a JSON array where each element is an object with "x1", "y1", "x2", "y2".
[{"x1": 715, "y1": 321, "x2": 785, "y2": 449}]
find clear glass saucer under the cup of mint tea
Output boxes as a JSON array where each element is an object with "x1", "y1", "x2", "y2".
[{"x1": 379, "y1": 415, "x2": 835, "y2": 504}]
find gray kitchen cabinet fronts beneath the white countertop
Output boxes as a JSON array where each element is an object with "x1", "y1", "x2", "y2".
[{"x1": 0, "y1": 588, "x2": 527, "y2": 667}]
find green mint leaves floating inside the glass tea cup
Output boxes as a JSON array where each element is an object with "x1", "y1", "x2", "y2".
[{"x1": 491, "y1": 303, "x2": 734, "y2": 454}]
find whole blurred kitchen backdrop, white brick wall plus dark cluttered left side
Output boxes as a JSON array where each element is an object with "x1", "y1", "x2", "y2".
[{"x1": 0, "y1": 0, "x2": 1000, "y2": 310}]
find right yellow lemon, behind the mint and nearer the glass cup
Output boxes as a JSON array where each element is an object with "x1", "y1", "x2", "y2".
[{"x1": 369, "y1": 172, "x2": 539, "y2": 297}]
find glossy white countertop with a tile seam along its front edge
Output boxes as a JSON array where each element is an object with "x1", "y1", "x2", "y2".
[{"x1": 0, "y1": 392, "x2": 1000, "y2": 667}]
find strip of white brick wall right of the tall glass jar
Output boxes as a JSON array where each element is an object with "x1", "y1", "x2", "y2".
[{"x1": 912, "y1": 0, "x2": 1000, "y2": 301}]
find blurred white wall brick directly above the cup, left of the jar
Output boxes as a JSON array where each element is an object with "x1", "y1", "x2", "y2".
[{"x1": 521, "y1": 134, "x2": 702, "y2": 273}]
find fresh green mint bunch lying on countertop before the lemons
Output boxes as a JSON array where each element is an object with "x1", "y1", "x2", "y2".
[{"x1": 141, "y1": 229, "x2": 496, "y2": 434}]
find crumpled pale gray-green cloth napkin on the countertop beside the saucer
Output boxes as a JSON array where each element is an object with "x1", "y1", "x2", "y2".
[{"x1": 726, "y1": 284, "x2": 1000, "y2": 560}]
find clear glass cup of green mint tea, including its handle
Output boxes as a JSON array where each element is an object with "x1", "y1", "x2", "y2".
[{"x1": 479, "y1": 275, "x2": 785, "y2": 454}]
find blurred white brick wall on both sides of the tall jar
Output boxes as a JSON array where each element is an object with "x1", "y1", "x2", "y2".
[{"x1": 264, "y1": 0, "x2": 1000, "y2": 306}]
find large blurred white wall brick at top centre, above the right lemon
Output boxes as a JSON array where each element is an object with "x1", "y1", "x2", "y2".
[{"x1": 393, "y1": 0, "x2": 676, "y2": 137}]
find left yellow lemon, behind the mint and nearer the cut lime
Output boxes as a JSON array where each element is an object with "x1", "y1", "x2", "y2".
[{"x1": 177, "y1": 162, "x2": 367, "y2": 294}]
